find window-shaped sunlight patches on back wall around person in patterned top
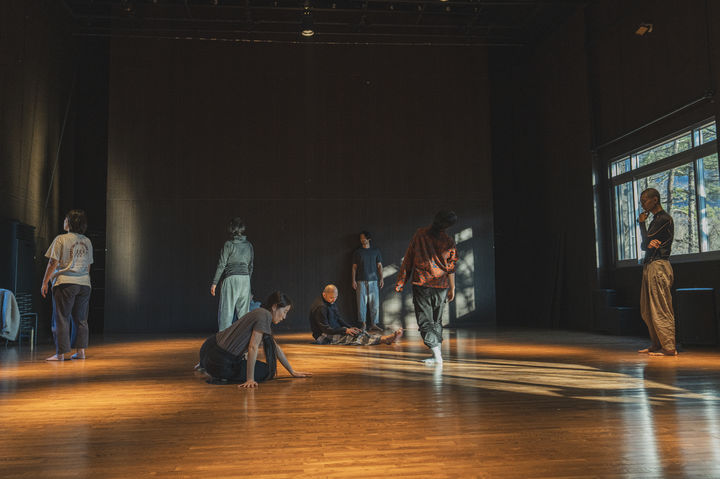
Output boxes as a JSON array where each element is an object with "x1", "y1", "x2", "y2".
[{"x1": 380, "y1": 228, "x2": 476, "y2": 329}]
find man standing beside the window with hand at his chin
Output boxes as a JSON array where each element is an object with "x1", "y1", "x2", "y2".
[{"x1": 638, "y1": 188, "x2": 677, "y2": 356}]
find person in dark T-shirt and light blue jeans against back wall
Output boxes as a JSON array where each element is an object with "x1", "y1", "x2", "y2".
[{"x1": 352, "y1": 231, "x2": 385, "y2": 333}]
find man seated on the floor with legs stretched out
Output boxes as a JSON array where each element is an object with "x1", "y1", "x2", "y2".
[{"x1": 310, "y1": 284, "x2": 402, "y2": 346}]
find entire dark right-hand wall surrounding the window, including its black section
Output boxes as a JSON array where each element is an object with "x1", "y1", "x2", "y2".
[{"x1": 491, "y1": 0, "x2": 720, "y2": 329}]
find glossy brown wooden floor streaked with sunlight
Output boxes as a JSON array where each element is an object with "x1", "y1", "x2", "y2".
[{"x1": 0, "y1": 330, "x2": 720, "y2": 478}]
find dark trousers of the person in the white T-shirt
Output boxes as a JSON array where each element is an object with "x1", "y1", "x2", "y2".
[{"x1": 52, "y1": 284, "x2": 90, "y2": 354}]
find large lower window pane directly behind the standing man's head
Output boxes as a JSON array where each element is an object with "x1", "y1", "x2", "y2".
[{"x1": 638, "y1": 163, "x2": 700, "y2": 255}]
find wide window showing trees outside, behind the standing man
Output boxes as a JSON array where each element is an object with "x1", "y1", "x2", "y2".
[{"x1": 608, "y1": 121, "x2": 720, "y2": 263}]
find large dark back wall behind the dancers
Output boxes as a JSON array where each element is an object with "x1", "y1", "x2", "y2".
[{"x1": 106, "y1": 39, "x2": 495, "y2": 331}]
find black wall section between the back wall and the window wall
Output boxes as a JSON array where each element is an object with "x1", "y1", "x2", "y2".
[{"x1": 491, "y1": 11, "x2": 595, "y2": 328}]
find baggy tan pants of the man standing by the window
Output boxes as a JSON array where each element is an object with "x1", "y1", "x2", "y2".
[{"x1": 640, "y1": 259, "x2": 675, "y2": 351}]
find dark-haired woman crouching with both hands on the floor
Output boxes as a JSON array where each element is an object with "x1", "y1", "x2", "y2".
[{"x1": 196, "y1": 291, "x2": 312, "y2": 388}]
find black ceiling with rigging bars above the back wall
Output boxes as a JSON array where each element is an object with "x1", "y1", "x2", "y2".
[{"x1": 63, "y1": 0, "x2": 589, "y2": 46}]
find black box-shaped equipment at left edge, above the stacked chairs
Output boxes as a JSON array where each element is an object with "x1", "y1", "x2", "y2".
[{"x1": 0, "y1": 219, "x2": 39, "y2": 296}]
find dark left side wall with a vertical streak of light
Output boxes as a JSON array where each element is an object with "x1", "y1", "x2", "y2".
[{"x1": 0, "y1": 0, "x2": 76, "y2": 338}]
